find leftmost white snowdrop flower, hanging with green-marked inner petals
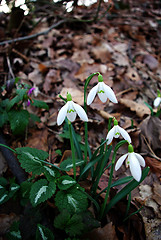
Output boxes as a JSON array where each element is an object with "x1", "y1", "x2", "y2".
[{"x1": 57, "y1": 93, "x2": 88, "y2": 125}]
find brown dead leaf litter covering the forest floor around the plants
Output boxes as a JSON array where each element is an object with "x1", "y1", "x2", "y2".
[{"x1": 0, "y1": 0, "x2": 161, "y2": 240}]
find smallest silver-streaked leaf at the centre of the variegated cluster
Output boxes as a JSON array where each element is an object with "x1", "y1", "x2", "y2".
[{"x1": 58, "y1": 175, "x2": 77, "y2": 190}]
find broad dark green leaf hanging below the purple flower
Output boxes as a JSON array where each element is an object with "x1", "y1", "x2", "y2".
[{"x1": 8, "y1": 110, "x2": 30, "y2": 135}]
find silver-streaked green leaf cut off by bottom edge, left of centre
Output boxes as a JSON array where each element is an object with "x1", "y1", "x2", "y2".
[{"x1": 36, "y1": 224, "x2": 54, "y2": 240}]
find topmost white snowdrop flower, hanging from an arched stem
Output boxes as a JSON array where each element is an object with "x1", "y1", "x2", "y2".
[{"x1": 87, "y1": 73, "x2": 118, "y2": 105}]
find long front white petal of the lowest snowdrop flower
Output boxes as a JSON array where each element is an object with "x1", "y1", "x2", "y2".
[{"x1": 129, "y1": 152, "x2": 142, "y2": 182}]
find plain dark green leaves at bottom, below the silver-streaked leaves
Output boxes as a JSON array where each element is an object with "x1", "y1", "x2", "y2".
[{"x1": 54, "y1": 210, "x2": 85, "y2": 236}]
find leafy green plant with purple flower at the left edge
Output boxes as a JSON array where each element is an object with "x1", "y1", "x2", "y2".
[{"x1": 0, "y1": 80, "x2": 48, "y2": 135}]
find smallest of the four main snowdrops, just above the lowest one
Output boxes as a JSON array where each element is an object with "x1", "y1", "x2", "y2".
[{"x1": 106, "y1": 119, "x2": 131, "y2": 145}]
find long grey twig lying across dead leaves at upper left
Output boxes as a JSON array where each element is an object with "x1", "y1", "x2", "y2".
[{"x1": 0, "y1": 19, "x2": 68, "y2": 46}]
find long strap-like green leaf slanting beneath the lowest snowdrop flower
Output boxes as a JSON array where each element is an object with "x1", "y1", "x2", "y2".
[{"x1": 105, "y1": 167, "x2": 149, "y2": 213}]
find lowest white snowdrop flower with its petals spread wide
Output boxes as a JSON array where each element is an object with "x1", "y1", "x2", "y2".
[{"x1": 115, "y1": 144, "x2": 145, "y2": 182}]
